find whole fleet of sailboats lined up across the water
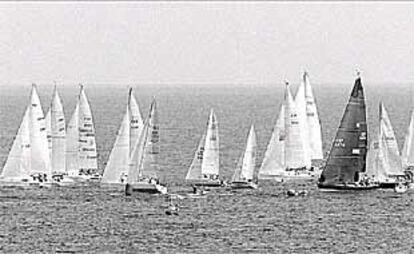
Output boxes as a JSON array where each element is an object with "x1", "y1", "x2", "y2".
[{"x1": 0, "y1": 72, "x2": 414, "y2": 195}]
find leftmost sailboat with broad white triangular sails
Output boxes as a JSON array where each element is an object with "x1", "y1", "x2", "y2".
[{"x1": 0, "y1": 84, "x2": 51, "y2": 186}]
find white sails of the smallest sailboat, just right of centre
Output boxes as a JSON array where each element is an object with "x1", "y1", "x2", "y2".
[{"x1": 233, "y1": 125, "x2": 257, "y2": 181}]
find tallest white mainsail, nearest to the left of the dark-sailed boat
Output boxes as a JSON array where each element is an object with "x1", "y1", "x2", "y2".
[{"x1": 302, "y1": 72, "x2": 323, "y2": 160}]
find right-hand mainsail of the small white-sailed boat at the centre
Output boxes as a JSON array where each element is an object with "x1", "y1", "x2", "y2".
[{"x1": 201, "y1": 109, "x2": 219, "y2": 175}]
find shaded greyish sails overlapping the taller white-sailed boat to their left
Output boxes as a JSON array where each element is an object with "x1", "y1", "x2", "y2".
[{"x1": 127, "y1": 99, "x2": 160, "y2": 184}]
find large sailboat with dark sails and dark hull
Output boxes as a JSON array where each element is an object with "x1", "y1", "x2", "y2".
[{"x1": 318, "y1": 75, "x2": 378, "y2": 191}]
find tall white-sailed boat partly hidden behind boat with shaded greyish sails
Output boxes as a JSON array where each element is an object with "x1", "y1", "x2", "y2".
[{"x1": 101, "y1": 88, "x2": 144, "y2": 185}]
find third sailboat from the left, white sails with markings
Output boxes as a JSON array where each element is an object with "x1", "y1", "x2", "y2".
[{"x1": 66, "y1": 85, "x2": 100, "y2": 182}]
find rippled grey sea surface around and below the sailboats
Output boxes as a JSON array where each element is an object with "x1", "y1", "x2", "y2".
[{"x1": 0, "y1": 81, "x2": 414, "y2": 253}]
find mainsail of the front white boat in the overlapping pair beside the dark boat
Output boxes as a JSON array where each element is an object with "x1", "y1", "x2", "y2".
[{"x1": 285, "y1": 81, "x2": 311, "y2": 169}]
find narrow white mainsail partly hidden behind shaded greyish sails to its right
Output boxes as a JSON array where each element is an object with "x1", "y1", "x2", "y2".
[{"x1": 128, "y1": 88, "x2": 144, "y2": 157}]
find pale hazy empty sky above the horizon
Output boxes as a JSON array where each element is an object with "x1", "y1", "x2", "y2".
[{"x1": 0, "y1": 2, "x2": 414, "y2": 85}]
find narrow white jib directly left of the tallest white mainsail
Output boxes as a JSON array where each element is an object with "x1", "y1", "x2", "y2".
[{"x1": 295, "y1": 79, "x2": 311, "y2": 166}]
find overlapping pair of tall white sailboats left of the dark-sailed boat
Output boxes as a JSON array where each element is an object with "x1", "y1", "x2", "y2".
[{"x1": 259, "y1": 72, "x2": 322, "y2": 180}]
